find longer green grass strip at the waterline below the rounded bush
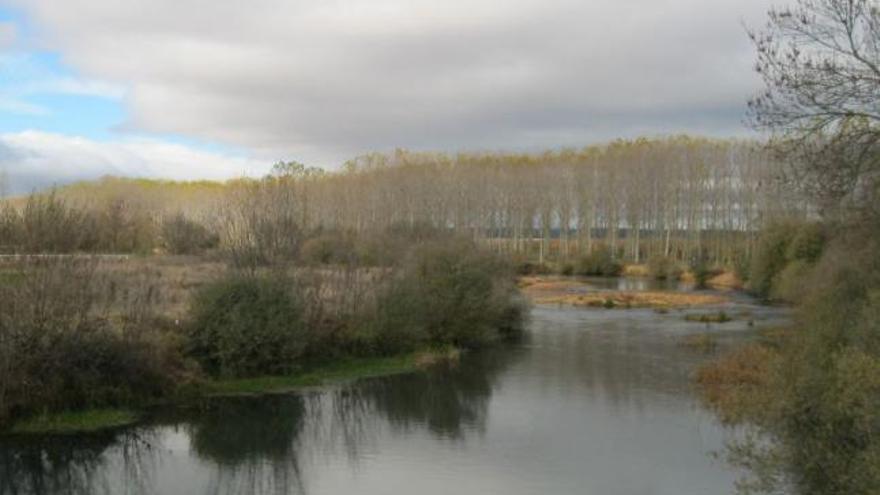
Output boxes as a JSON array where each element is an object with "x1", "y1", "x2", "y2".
[{"x1": 202, "y1": 353, "x2": 419, "y2": 396}]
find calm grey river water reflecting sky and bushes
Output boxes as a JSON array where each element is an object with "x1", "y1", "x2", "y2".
[{"x1": 0, "y1": 285, "x2": 784, "y2": 495}]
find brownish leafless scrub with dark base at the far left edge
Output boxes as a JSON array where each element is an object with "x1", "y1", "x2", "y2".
[{"x1": 0, "y1": 259, "x2": 183, "y2": 426}]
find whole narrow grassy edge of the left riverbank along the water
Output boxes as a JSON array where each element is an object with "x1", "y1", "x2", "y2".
[{"x1": 0, "y1": 348, "x2": 460, "y2": 435}]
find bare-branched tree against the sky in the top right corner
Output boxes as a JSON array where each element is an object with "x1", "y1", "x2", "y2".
[{"x1": 749, "y1": 0, "x2": 880, "y2": 209}]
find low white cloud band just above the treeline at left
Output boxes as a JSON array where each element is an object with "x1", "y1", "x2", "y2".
[{"x1": 0, "y1": 131, "x2": 269, "y2": 193}]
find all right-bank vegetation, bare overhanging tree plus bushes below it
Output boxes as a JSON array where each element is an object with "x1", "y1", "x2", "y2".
[{"x1": 699, "y1": 0, "x2": 880, "y2": 495}]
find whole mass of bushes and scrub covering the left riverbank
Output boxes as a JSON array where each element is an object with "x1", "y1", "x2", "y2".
[{"x1": 0, "y1": 221, "x2": 524, "y2": 427}]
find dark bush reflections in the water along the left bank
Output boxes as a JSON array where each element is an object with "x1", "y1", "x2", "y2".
[{"x1": 0, "y1": 350, "x2": 516, "y2": 495}]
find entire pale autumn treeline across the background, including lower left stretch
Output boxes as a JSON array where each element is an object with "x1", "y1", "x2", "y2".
[{"x1": 0, "y1": 137, "x2": 812, "y2": 265}]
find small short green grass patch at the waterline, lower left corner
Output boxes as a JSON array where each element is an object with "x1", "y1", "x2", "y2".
[{"x1": 10, "y1": 409, "x2": 139, "y2": 434}]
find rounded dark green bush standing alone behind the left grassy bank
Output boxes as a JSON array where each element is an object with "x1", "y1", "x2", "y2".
[{"x1": 186, "y1": 275, "x2": 309, "y2": 377}]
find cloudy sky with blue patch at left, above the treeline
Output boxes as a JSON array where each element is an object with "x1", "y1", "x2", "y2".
[{"x1": 0, "y1": 0, "x2": 771, "y2": 193}]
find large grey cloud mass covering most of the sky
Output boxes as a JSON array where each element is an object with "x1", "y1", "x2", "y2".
[{"x1": 0, "y1": 0, "x2": 768, "y2": 165}]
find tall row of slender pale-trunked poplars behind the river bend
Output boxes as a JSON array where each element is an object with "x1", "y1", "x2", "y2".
[{"x1": 316, "y1": 137, "x2": 809, "y2": 263}]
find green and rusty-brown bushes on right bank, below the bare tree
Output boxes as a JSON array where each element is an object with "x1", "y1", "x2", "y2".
[{"x1": 700, "y1": 233, "x2": 880, "y2": 494}]
